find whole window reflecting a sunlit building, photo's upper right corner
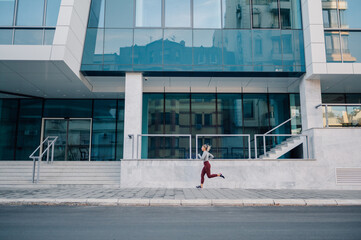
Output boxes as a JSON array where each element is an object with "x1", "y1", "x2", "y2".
[{"x1": 322, "y1": 0, "x2": 361, "y2": 62}]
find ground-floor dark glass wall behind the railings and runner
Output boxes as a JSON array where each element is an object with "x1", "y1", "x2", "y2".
[{"x1": 142, "y1": 93, "x2": 301, "y2": 159}]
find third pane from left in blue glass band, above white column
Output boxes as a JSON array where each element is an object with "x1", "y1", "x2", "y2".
[{"x1": 134, "y1": 29, "x2": 163, "y2": 64}]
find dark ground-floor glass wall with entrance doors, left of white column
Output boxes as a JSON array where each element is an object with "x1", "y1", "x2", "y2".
[{"x1": 0, "y1": 99, "x2": 124, "y2": 161}]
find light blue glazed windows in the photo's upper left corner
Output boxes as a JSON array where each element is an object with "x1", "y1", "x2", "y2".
[{"x1": 0, "y1": 0, "x2": 61, "y2": 45}]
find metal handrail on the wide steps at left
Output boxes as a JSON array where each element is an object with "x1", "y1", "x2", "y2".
[{"x1": 29, "y1": 136, "x2": 58, "y2": 183}]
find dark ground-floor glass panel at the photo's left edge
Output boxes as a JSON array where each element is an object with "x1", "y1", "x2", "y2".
[{"x1": 0, "y1": 99, "x2": 18, "y2": 160}]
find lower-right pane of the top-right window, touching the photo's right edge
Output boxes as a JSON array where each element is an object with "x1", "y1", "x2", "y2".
[{"x1": 341, "y1": 32, "x2": 361, "y2": 62}]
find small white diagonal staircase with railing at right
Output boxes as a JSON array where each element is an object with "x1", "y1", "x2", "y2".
[{"x1": 259, "y1": 136, "x2": 304, "y2": 159}]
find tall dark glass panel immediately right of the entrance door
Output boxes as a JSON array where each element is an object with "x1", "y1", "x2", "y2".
[{"x1": 91, "y1": 100, "x2": 117, "y2": 161}]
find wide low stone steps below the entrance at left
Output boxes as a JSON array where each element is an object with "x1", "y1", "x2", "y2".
[{"x1": 0, "y1": 161, "x2": 120, "y2": 186}]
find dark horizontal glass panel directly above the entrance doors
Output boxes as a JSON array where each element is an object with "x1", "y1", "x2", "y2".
[{"x1": 44, "y1": 99, "x2": 92, "y2": 118}]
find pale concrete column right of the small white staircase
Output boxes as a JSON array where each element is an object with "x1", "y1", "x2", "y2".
[{"x1": 300, "y1": 78, "x2": 323, "y2": 131}]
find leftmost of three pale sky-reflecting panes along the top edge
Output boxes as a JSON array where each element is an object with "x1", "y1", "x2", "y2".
[{"x1": 135, "y1": 0, "x2": 162, "y2": 27}]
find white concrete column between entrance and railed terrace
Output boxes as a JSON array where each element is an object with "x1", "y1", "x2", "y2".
[{"x1": 123, "y1": 73, "x2": 143, "y2": 159}]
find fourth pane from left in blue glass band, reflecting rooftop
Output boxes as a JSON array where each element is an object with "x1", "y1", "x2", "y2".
[{"x1": 164, "y1": 29, "x2": 192, "y2": 65}]
